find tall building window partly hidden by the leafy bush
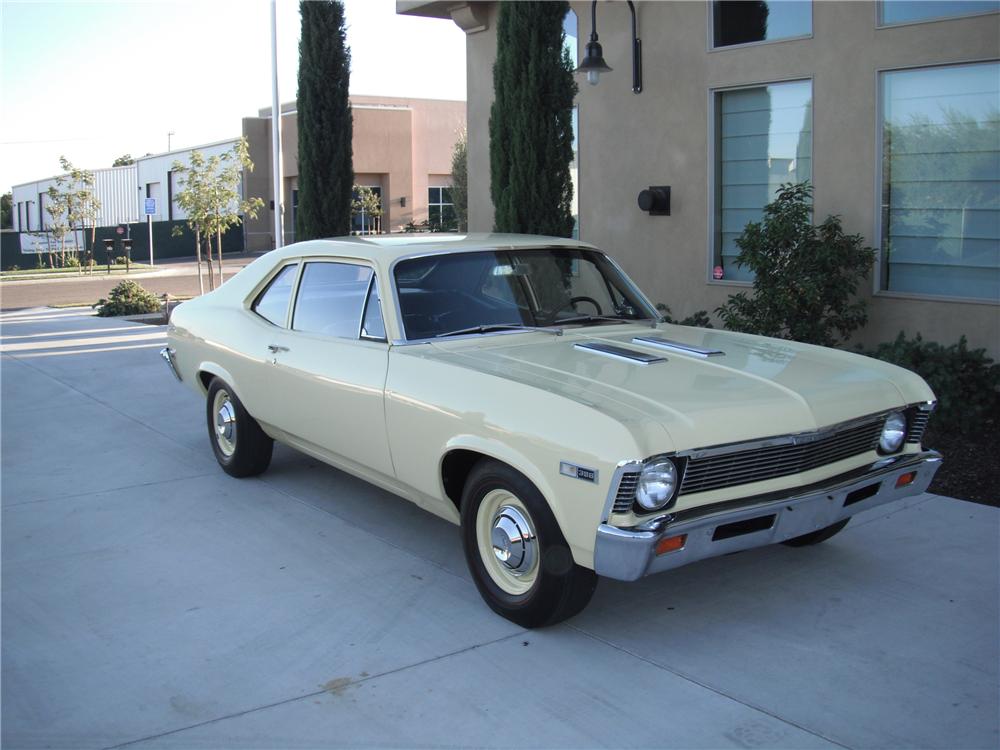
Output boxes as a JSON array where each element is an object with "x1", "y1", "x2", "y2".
[{"x1": 713, "y1": 81, "x2": 812, "y2": 281}]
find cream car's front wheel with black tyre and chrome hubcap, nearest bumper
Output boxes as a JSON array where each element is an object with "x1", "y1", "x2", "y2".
[{"x1": 462, "y1": 460, "x2": 597, "y2": 628}]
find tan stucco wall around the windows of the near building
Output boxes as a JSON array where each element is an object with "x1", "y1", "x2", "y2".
[{"x1": 397, "y1": 2, "x2": 1000, "y2": 358}]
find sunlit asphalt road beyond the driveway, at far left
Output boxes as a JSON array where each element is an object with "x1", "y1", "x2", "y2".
[{"x1": 0, "y1": 255, "x2": 266, "y2": 310}]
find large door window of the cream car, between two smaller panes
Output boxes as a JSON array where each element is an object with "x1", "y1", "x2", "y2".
[{"x1": 292, "y1": 263, "x2": 372, "y2": 339}]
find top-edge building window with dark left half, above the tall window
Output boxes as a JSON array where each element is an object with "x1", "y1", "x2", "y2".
[{"x1": 712, "y1": 0, "x2": 812, "y2": 47}]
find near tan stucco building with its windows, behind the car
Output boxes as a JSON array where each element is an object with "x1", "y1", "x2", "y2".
[{"x1": 397, "y1": 0, "x2": 1000, "y2": 358}]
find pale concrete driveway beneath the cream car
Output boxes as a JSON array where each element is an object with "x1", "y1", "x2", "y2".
[{"x1": 0, "y1": 309, "x2": 1000, "y2": 749}]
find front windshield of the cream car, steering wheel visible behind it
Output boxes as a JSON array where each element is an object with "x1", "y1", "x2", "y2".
[{"x1": 395, "y1": 248, "x2": 650, "y2": 341}]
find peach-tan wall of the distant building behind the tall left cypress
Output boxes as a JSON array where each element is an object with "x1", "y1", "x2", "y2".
[{"x1": 243, "y1": 96, "x2": 465, "y2": 251}]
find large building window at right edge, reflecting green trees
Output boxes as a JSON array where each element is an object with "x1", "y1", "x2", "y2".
[{"x1": 880, "y1": 62, "x2": 1000, "y2": 301}]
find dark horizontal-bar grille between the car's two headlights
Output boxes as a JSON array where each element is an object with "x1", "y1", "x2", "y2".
[{"x1": 680, "y1": 415, "x2": 885, "y2": 504}]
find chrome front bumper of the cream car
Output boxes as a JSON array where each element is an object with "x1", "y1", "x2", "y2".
[{"x1": 594, "y1": 451, "x2": 941, "y2": 581}]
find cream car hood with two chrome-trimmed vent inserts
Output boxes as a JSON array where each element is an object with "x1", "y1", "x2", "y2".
[{"x1": 424, "y1": 324, "x2": 933, "y2": 450}]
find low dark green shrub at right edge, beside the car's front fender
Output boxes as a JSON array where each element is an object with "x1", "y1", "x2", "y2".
[{"x1": 861, "y1": 331, "x2": 1000, "y2": 433}]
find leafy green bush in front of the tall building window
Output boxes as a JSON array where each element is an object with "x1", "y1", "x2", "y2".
[{"x1": 716, "y1": 182, "x2": 875, "y2": 346}]
